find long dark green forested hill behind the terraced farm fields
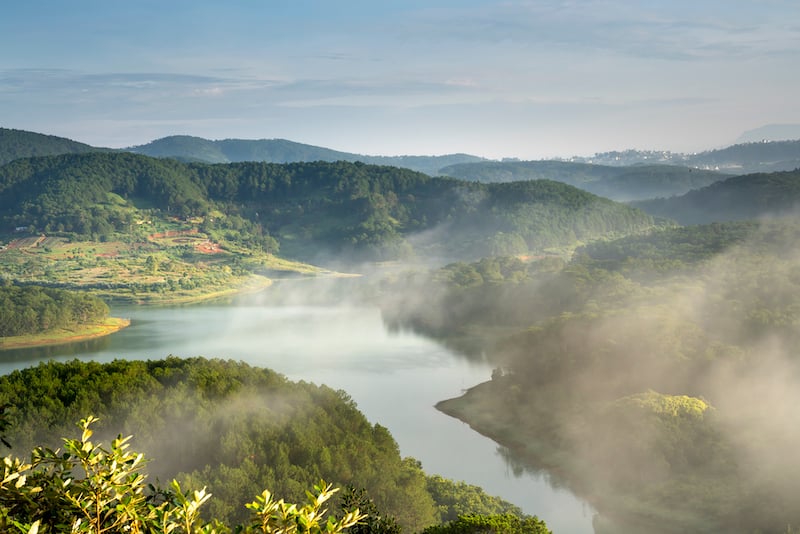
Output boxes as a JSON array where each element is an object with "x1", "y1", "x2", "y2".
[{"x1": 0, "y1": 153, "x2": 653, "y2": 259}]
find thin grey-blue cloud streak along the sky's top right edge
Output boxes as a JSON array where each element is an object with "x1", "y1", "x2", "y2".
[{"x1": 396, "y1": 1, "x2": 797, "y2": 61}]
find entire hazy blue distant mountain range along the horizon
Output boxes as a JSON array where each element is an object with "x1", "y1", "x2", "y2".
[{"x1": 0, "y1": 125, "x2": 800, "y2": 201}]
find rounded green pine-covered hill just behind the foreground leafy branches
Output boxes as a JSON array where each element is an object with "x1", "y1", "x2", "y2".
[{"x1": 0, "y1": 358, "x2": 436, "y2": 530}]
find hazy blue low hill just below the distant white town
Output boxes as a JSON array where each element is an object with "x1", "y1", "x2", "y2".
[{"x1": 441, "y1": 161, "x2": 730, "y2": 202}]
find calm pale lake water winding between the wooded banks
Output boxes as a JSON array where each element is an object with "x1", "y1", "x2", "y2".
[{"x1": 0, "y1": 296, "x2": 593, "y2": 534}]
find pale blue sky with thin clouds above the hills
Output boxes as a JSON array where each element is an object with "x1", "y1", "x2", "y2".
[{"x1": 0, "y1": 0, "x2": 800, "y2": 159}]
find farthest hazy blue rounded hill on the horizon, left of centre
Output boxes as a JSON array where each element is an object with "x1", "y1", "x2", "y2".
[{"x1": 127, "y1": 135, "x2": 482, "y2": 175}]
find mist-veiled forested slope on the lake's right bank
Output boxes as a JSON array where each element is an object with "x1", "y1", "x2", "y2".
[{"x1": 383, "y1": 218, "x2": 800, "y2": 532}]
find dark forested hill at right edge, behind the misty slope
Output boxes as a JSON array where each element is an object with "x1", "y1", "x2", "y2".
[{"x1": 632, "y1": 170, "x2": 800, "y2": 224}]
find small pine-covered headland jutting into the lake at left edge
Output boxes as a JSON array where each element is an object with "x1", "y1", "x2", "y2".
[{"x1": 0, "y1": 286, "x2": 108, "y2": 337}]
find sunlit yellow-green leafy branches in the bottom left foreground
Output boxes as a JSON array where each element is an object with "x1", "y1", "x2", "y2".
[{"x1": 0, "y1": 416, "x2": 366, "y2": 534}]
